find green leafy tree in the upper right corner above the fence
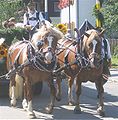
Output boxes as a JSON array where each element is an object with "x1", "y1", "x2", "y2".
[{"x1": 102, "y1": 0, "x2": 118, "y2": 38}]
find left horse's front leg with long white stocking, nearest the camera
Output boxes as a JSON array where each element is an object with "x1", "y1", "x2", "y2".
[{"x1": 25, "y1": 77, "x2": 36, "y2": 118}]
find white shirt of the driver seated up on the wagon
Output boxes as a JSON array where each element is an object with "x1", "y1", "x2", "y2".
[{"x1": 23, "y1": 10, "x2": 44, "y2": 27}]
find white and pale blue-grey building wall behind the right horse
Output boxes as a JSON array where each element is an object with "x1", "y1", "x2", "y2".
[{"x1": 60, "y1": 0, "x2": 96, "y2": 28}]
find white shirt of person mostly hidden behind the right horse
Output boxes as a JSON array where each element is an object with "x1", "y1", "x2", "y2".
[{"x1": 102, "y1": 38, "x2": 111, "y2": 59}]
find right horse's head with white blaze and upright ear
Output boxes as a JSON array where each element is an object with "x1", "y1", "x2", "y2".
[{"x1": 83, "y1": 29, "x2": 104, "y2": 68}]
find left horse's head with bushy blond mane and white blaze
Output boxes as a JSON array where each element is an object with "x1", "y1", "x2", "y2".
[{"x1": 31, "y1": 24, "x2": 63, "y2": 64}]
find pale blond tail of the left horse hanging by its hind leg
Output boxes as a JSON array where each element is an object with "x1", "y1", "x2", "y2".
[{"x1": 9, "y1": 74, "x2": 23, "y2": 99}]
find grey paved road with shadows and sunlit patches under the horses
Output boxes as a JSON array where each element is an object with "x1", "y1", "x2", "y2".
[{"x1": 0, "y1": 69, "x2": 118, "y2": 120}]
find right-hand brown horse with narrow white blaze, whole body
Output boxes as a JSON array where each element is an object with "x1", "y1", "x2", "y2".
[{"x1": 55, "y1": 29, "x2": 104, "y2": 115}]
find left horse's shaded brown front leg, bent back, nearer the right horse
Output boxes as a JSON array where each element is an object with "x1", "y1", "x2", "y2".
[{"x1": 45, "y1": 78, "x2": 56, "y2": 114}]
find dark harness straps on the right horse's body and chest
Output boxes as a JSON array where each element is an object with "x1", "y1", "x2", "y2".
[{"x1": 54, "y1": 33, "x2": 103, "y2": 73}]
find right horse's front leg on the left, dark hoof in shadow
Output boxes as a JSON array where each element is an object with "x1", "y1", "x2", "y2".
[{"x1": 74, "y1": 79, "x2": 81, "y2": 114}]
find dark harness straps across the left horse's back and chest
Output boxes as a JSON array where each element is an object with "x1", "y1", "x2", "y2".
[{"x1": 0, "y1": 40, "x2": 57, "y2": 79}]
